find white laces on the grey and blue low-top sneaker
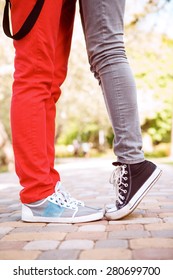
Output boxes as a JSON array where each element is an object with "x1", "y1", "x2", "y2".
[{"x1": 48, "y1": 182, "x2": 84, "y2": 210}]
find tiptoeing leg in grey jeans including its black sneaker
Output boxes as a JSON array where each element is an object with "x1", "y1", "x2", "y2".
[{"x1": 80, "y1": 0, "x2": 161, "y2": 219}]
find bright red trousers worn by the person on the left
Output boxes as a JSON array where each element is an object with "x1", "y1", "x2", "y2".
[{"x1": 11, "y1": 0, "x2": 76, "y2": 203}]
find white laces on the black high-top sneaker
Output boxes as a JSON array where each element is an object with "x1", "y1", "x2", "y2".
[{"x1": 109, "y1": 165, "x2": 128, "y2": 205}]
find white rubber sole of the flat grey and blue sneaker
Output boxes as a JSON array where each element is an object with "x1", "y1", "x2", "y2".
[{"x1": 22, "y1": 204, "x2": 105, "y2": 224}]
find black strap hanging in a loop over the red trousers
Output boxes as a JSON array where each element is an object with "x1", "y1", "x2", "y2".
[{"x1": 3, "y1": 0, "x2": 45, "y2": 40}]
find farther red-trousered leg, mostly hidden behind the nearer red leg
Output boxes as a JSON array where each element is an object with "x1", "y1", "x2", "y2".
[{"x1": 45, "y1": 0, "x2": 76, "y2": 188}]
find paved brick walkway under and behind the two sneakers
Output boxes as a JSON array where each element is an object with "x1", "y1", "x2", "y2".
[{"x1": 0, "y1": 159, "x2": 173, "y2": 260}]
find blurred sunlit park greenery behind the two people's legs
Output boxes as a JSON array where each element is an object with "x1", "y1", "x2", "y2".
[{"x1": 0, "y1": 0, "x2": 173, "y2": 172}]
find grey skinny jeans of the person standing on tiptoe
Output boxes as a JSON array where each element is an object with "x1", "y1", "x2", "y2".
[{"x1": 79, "y1": 0, "x2": 144, "y2": 164}]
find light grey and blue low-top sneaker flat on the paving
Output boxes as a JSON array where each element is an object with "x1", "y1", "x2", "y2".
[{"x1": 22, "y1": 182, "x2": 104, "y2": 223}]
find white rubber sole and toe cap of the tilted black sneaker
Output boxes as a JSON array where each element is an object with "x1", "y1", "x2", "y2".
[{"x1": 105, "y1": 167, "x2": 162, "y2": 220}]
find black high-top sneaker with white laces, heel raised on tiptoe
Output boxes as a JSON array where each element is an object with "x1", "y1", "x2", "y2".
[{"x1": 105, "y1": 160, "x2": 162, "y2": 220}]
